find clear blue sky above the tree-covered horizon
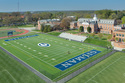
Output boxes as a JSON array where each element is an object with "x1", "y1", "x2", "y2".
[{"x1": 0, "y1": 0, "x2": 125, "y2": 12}]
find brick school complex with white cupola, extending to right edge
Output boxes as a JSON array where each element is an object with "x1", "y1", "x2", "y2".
[{"x1": 70, "y1": 15, "x2": 125, "y2": 48}]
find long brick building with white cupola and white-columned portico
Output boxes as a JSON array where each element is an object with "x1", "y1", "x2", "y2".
[{"x1": 71, "y1": 15, "x2": 117, "y2": 34}]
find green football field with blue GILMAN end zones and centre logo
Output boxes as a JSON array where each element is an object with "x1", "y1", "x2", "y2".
[{"x1": 0, "y1": 34, "x2": 109, "y2": 79}]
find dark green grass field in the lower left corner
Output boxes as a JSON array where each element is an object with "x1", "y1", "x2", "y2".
[{"x1": 0, "y1": 49, "x2": 45, "y2": 83}]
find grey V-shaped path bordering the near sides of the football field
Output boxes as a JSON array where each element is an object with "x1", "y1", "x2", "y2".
[{"x1": 0, "y1": 47, "x2": 116, "y2": 83}]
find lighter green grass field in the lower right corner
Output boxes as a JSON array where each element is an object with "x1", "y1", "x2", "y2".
[{"x1": 67, "y1": 52, "x2": 125, "y2": 83}]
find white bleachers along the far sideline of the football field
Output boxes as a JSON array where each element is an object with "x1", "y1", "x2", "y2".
[{"x1": 59, "y1": 33, "x2": 87, "y2": 42}]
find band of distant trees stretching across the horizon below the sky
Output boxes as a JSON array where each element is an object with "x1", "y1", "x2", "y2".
[{"x1": 0, "y1": 9, "x2": 125, "y2": 28}]
